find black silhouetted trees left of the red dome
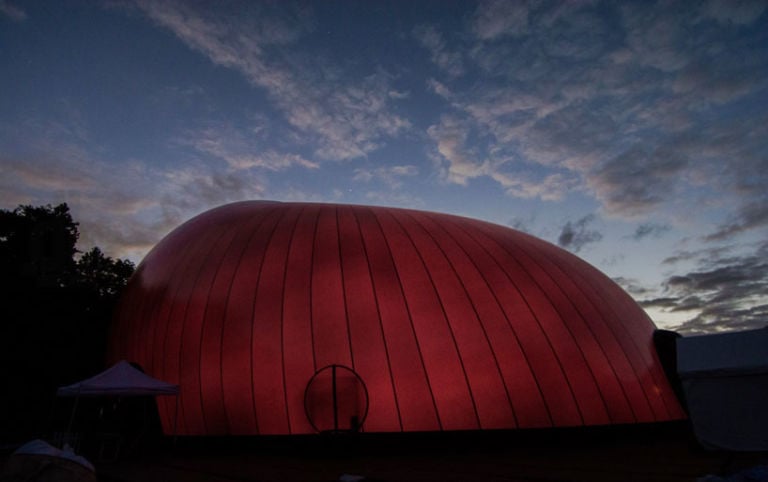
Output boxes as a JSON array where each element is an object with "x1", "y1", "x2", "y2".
[{"x1": 0, "y1": 204, "x2": 134, "y2": 441}]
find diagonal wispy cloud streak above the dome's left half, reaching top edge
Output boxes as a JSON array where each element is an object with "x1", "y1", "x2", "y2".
[{"x1": 138, "y1": 1, "x2": 411, "y2": 160}]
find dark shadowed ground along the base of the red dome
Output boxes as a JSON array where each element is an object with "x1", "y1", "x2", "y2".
[{"x1": 67, "y1": 423, "x2": 768, "y2": 482}]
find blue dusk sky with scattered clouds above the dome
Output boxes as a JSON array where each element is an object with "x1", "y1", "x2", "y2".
[{"x1": 0, "y1": 0, "x2": 768, "y2": 333}]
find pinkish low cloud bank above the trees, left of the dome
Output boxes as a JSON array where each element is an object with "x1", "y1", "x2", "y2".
[{"x1": 0, "y1": 116, "x2": 267, "y2": 261}]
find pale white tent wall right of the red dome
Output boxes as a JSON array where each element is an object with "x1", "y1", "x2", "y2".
[{"x1": 677, "y1": 328, "x2": 768, "y2": 451}]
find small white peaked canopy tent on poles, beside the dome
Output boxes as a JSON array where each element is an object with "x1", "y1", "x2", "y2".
[{"x1": 56, "y1": 360, "x2": 179, "y2": 434}]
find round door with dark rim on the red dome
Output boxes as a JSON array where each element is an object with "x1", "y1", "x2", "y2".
[{"x1": 304, "y1": 365, "x2": 368, "y2": 432}]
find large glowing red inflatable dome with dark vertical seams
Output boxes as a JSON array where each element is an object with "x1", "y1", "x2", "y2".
[{"x1": 110, "y1": 201, "x2": 684, "y2": 435}]
